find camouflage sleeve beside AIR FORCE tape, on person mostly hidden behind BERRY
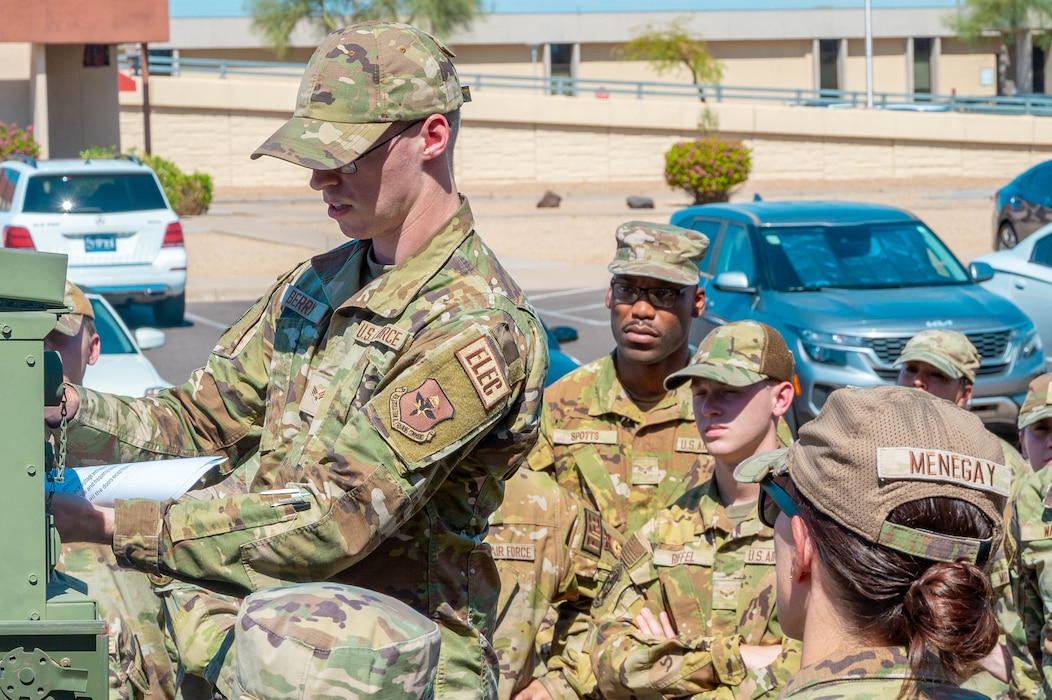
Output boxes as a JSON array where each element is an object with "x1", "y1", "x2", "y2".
[{"x1": 540, "y1": 504, "x2": 623, "y2": 698}]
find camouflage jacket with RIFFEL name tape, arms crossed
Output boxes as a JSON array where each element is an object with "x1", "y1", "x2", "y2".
[{"x1": 592, "y1": 479, "x2": 800, "y2": 698}]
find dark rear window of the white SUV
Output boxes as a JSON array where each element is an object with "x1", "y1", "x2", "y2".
[{"x1": 24, "y1": 173, "x2": 165, "y2": 214}]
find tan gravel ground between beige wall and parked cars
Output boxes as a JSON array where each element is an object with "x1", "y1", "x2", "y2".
[{"x1": 186, "y1": 178, "x2": 1003, "y2": 284}]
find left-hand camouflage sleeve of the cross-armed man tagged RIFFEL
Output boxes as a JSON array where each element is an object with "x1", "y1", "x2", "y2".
[{"x1": 591, "y1": 532, "x2": 746, "y2": 698}]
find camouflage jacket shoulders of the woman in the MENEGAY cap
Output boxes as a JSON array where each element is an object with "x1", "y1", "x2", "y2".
[{"x1": 778, "y1": 646, "x2": 987, "y2": 700}]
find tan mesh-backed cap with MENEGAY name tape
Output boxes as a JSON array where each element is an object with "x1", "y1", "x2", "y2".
[{"x1": 734, "y1": 386, "x2": 1012, "y2": 565}]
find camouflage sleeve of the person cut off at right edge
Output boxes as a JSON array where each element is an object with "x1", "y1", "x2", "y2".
[{"x1": 1005, "y1": 469, "x2": 1052, "y2": 697}]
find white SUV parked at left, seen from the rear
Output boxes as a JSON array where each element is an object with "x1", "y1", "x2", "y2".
[{"x1": 0, "y1": 156, "x2": 186, "y2": 325}]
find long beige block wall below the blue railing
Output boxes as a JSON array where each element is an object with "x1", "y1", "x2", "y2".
[{"x1": 120, "y1": 72, "x2": 1052, "y2": 187}]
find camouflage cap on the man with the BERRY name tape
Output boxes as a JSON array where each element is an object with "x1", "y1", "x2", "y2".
[{"x1": 252, "y1": 22, "x2": 464, "y2": 169}]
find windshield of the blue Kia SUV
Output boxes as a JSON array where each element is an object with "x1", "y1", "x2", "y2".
[{"x1": 760, "y1": 222, "x2": 970, "y2": 292}]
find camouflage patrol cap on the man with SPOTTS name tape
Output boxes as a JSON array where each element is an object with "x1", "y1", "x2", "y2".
[{"x1": 606, "y1": 221, "x2": 709, "y2": 285}]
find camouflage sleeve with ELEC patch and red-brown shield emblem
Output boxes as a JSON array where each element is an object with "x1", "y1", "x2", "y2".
[{"x1": 114, "y1": 311, "x2": 547, "y2": 591}]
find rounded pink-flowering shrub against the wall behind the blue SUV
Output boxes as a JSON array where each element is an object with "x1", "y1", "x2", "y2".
[{"x1": 665, "y1": 137, "x2": 752, "y2": 204}]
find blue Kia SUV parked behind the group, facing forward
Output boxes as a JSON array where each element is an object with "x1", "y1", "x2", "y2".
[{"x1": 671, "y1": 201, "x2": 1045, "y2": 436}]
